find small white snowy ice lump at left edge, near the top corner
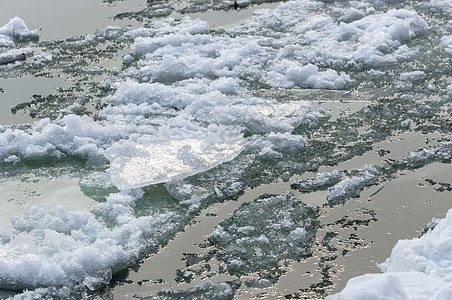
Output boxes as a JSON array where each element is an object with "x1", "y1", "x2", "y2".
[{"x1": 0, "y1": 17, "x2": 39, "y2": 47}]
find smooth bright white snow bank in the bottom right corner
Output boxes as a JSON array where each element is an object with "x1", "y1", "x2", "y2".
[{"x1": 327, "y1": 210, "x2": 452, "y2": 300}]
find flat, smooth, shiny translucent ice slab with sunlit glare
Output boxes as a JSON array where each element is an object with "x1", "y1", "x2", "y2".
[{"x1": 106, "y1": 127, "x2": 243, "y2": 190}]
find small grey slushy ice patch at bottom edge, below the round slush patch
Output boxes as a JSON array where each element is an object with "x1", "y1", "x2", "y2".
[{"x1": 147, "y1": 280, "x2": 241, "y2": 300}]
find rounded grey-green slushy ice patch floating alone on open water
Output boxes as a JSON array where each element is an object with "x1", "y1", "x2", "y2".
[{"x1": 209, "y1": 193, "x2": 317, "y2": 284}]
